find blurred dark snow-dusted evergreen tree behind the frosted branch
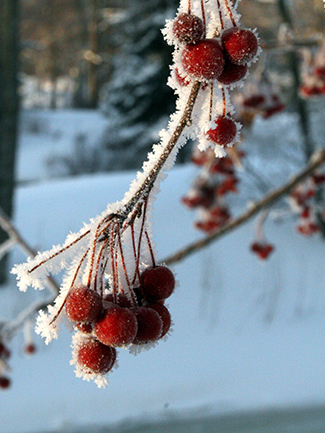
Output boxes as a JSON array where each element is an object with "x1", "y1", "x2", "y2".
[{"x1": 100, "y1": 0, "x2": 177, "y2": 170}]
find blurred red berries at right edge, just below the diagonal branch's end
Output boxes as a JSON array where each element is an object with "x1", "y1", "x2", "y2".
[{"x1": 290, "y1": 173, "x2": 325, "y2": 236}]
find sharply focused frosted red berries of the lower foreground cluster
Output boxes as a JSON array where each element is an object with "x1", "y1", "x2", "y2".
[{"x1": 65, "y1": 265, "x2": 175, "y2": 375}]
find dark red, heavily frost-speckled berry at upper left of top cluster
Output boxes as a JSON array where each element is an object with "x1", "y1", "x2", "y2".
[{"x1": 173, "y1": 13, "x2": 204, "y2": 44}]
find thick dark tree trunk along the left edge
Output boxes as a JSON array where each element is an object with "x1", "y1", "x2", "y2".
[{"x1": 0, "y1": 0, "x2": 19, "y2": 284}]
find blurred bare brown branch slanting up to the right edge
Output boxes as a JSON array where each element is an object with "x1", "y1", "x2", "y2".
[{"x1": 162, "y1": 150, "x2": 325, "y2": 265}]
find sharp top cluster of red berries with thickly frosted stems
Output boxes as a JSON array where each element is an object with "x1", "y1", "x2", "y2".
[{"x1": 164, "y1": 0, "x2": 259, "y2": 156}]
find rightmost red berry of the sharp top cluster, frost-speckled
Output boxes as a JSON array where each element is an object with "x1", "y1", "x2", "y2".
[{"x1": 221, "y1": 27, "x2": 258, "y2": 65}]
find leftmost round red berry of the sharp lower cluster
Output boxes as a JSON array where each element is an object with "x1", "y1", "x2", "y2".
[{"x1": 65, "y1": 285, "x2": 102, "y2": 322}]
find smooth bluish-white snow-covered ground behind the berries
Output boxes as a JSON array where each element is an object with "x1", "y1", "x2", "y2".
[{"x1": 0, "y1": 109, "x2": 325, "y2": 433}]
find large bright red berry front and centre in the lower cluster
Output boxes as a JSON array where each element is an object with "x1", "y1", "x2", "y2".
[{"x1": 94, "y1": 303, "x2": 138, "y2": 346}]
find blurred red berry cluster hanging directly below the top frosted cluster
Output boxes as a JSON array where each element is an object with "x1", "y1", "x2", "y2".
[{"x1": 182, "y1": 147, "x2": 243, "y2": 233}]
